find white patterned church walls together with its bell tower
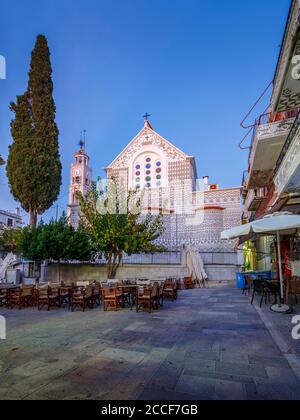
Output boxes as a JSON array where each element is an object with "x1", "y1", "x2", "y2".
[{"x1": 68, "y1": 118, "x2": 241, "y2": 261}]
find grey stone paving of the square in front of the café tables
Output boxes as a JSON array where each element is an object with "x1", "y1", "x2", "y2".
[{"x1": 0, "y1": 286, "x2": 300, "y2": 401}]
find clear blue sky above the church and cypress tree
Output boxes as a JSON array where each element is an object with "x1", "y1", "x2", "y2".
[{"x1": 0, "y1": 0, "x2": 290, "y2": 223}]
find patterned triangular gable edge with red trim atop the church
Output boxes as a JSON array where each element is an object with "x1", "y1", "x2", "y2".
[{"x1": 106, "y1": 120, "x2": 196, "y2": 170}]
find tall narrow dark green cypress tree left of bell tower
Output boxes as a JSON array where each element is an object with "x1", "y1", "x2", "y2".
[{"x1": 6, "y1": 35, "x2": 62, "y2": 226}]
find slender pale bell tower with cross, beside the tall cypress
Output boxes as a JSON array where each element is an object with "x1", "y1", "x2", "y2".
[{"x1": 68, "y1": 135, "x2": 92, "y2": 229}]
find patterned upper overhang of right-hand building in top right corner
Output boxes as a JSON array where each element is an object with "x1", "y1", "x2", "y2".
[{"x1": 271, "y1": 0, "x2": 300, "y2": 112}]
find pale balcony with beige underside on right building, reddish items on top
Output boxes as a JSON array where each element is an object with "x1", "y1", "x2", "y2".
[{"x1": 247, "y1": 110, "x2": 298, "y2": 189}]
